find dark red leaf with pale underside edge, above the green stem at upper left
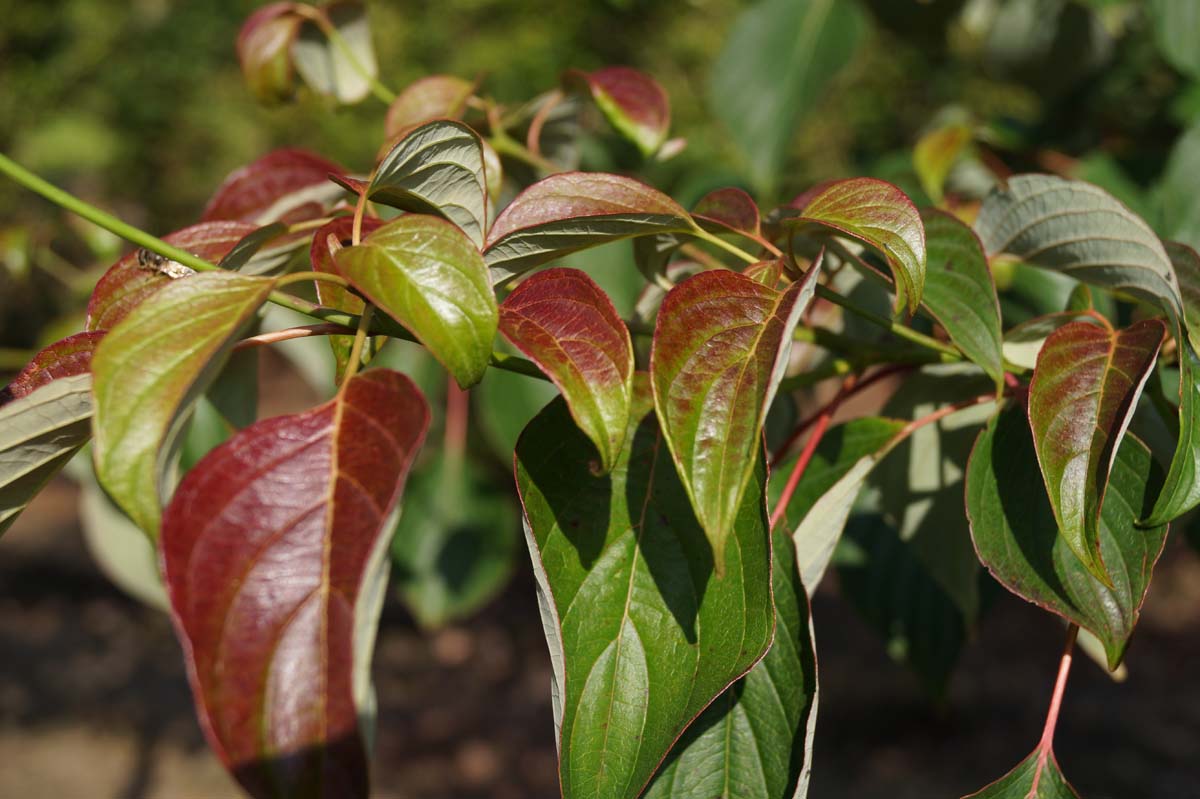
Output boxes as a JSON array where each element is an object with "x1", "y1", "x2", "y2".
[{"x1": 200, "y1": 149, "x2": 346, "y2": 226}]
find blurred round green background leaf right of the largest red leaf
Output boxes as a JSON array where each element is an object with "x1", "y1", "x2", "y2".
[{"x1": 391, "y1": 452, "x2": 521, "y2": 629}]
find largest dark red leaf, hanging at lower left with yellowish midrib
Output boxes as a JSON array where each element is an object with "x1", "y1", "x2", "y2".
[{"x1": 162, "y1": 370, "x2": 430, "y2": 799}]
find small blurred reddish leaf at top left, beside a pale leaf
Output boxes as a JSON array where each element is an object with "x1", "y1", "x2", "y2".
[{"x1": 238, "y1": 2, "x2": 301, "y2": 102}]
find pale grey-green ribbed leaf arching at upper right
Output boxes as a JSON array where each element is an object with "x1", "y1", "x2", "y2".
[{"x1": 974, "y1": 175, "x2": 1195, "y2": 344}]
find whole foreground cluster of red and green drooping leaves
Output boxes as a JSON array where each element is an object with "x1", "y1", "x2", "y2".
[{"x1": 0, "y1": 0, "x2": 1200, "y2": 799}]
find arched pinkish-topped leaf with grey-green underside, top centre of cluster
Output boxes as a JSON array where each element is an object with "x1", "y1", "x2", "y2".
[{"x1": 484, "y1": 172, "x2": 695, "y2": 283}]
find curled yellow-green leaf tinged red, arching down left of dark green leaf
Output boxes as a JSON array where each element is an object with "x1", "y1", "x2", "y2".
[{"x1": 782, "y1": 178, "x2": 926, "y2": 313}]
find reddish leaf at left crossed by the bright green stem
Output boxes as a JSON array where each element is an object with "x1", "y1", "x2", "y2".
[{"x1": 84, "y1": 222, "x2": 256, "y2": 330}]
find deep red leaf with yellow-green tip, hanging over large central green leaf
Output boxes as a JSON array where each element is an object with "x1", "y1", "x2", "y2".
[{"x1": 500, "y1": 269, "x2": 634, "y2": 471}]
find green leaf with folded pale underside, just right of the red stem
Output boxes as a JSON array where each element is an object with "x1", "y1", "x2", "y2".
[{"x1": 768, "y1": 416, "x2": 906, "y2": 587}]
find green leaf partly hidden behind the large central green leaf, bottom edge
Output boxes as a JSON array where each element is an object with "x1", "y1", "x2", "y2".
[{"x1": 644, "y1": 527, "x2": 817, "y2": 799}]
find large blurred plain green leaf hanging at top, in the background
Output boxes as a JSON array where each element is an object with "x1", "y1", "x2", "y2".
[{"x1": 708, "y1": 0, "x2": 868, "y2": 196}]
